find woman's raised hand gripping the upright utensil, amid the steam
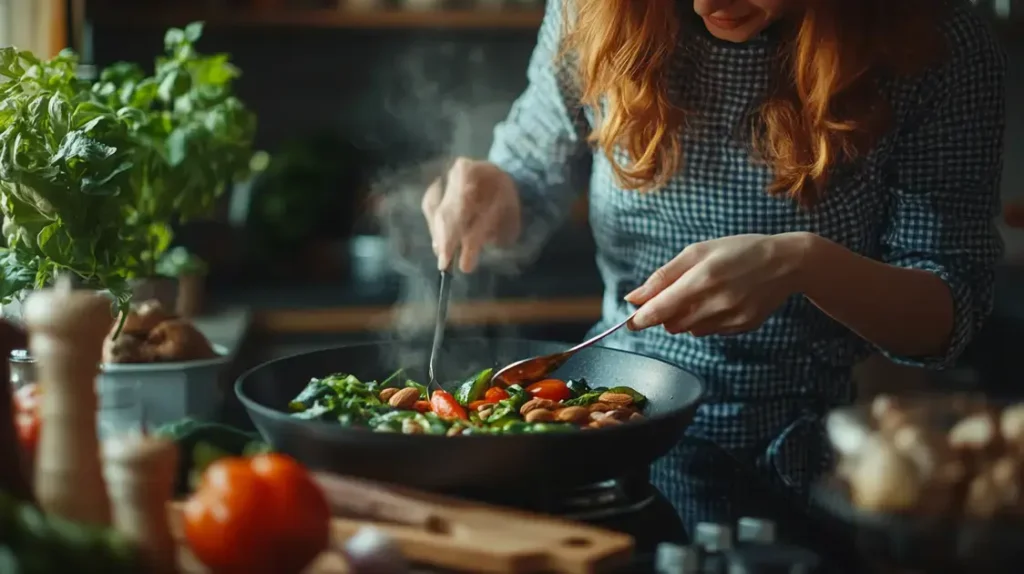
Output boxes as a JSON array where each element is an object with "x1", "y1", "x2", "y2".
[{"x1": 423, "y1": 158, "x2": 522, "y2": 273}]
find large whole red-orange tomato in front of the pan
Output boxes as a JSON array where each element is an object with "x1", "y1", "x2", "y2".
[{"x1": 183, "y1": 453, "x2": 331, "y2": 574}]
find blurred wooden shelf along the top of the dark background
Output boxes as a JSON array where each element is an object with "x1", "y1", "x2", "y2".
[{"x1": 88, "y1": 8, "x2": 544, "y2": 30}]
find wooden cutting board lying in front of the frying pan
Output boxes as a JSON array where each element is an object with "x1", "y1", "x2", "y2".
[{"x1": 170, "y1": 475, "x2": 634, "y2": 574}]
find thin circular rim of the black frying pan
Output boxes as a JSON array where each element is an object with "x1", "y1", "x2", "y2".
[{"x1": 234, "y1": 337, "x2": 706, "y2": 442}]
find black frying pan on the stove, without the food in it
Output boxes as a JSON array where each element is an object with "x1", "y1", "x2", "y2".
[{"x1": 234, "y1": 339, "x2": 702, "y2": 493}]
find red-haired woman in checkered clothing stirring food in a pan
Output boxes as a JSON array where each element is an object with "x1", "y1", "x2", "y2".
[{"x1": 423, "y1": 0, "x2": 1005, "y2": 509}]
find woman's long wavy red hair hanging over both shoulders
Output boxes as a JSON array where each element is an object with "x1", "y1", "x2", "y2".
[{"x1": 561, "y1": 0, "x2": 943, "y2": 205}]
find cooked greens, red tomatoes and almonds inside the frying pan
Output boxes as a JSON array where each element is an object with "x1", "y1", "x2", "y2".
[{"x1": 288, "y1": 368, "x2": 647, "y2": 436}]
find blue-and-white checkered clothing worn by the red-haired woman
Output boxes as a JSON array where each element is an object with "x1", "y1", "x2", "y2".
[{"x1": 489, "y1": 0, "x2": 1006, "y2": 509}]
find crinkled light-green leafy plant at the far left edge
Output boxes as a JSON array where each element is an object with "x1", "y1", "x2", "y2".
[{"x1": 0, "y1": 47, "x2": 137, "y2": 307}]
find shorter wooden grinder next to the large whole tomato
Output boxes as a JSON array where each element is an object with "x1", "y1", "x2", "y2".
[{"x1": 103, "y1": 433, "x2": 178, "y2": 574}]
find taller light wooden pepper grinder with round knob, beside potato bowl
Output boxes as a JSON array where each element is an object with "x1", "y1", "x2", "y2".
[{"x1": 25, "y1": 280, "x2": 113, "y2": 526}]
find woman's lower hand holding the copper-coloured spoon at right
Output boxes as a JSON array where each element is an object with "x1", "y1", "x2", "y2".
[{"x1": 626, "y1": 232, "x2": 813, "y2": 337}]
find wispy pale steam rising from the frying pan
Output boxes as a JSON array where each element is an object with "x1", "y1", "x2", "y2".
[{"x1": 364, "y1": 43, "x2": 552, "y2": 377}]
